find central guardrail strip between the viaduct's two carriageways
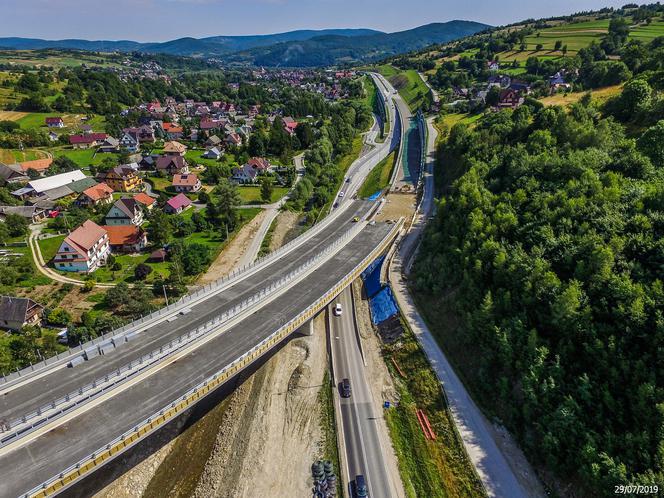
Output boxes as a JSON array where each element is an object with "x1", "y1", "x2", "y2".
[{"x1": 0, "y1": 225, "x2": 362, "y2": 448}]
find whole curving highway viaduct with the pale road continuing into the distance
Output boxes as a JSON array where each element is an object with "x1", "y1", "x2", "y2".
[{"x1": 0, "y1": 72, "x2": 401, "y2": 497}]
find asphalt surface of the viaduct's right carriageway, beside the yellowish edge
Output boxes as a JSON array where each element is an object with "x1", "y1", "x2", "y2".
[{"x1": 0, "y1": 224, "x2": 392, "y2": 497}]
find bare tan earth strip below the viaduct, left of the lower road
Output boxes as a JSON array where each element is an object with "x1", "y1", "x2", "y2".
[{"x1": 194, "y1": 315, "x2": 327, "y2": 498}]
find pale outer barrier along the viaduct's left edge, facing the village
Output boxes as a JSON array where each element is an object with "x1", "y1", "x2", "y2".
[{"x1": 2, "y1": 196, "x2": 368, "y2": 387}]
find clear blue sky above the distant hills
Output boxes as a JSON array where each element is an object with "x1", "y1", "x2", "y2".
[{"x1": 0, "y1": 0, "x2": 644, "y2": 41}]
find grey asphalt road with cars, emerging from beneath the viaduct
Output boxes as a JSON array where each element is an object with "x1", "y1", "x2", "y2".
[{"x1": 328, "y1": 288, "x2": 397, "y2": 498}]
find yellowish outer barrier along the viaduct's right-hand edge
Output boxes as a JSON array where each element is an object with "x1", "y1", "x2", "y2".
[{"x1": 21, "y1": 218, "x2": 404, "y2": 498}]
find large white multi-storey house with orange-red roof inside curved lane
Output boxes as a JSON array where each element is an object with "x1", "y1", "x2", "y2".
[{"x1": 53, "y1": 220, "x2": 110, "y2": 273}]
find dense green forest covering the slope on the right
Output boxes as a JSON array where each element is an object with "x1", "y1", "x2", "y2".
[{"x1": 414, "y1": 50, "x2": 664, "y2": 496}]
